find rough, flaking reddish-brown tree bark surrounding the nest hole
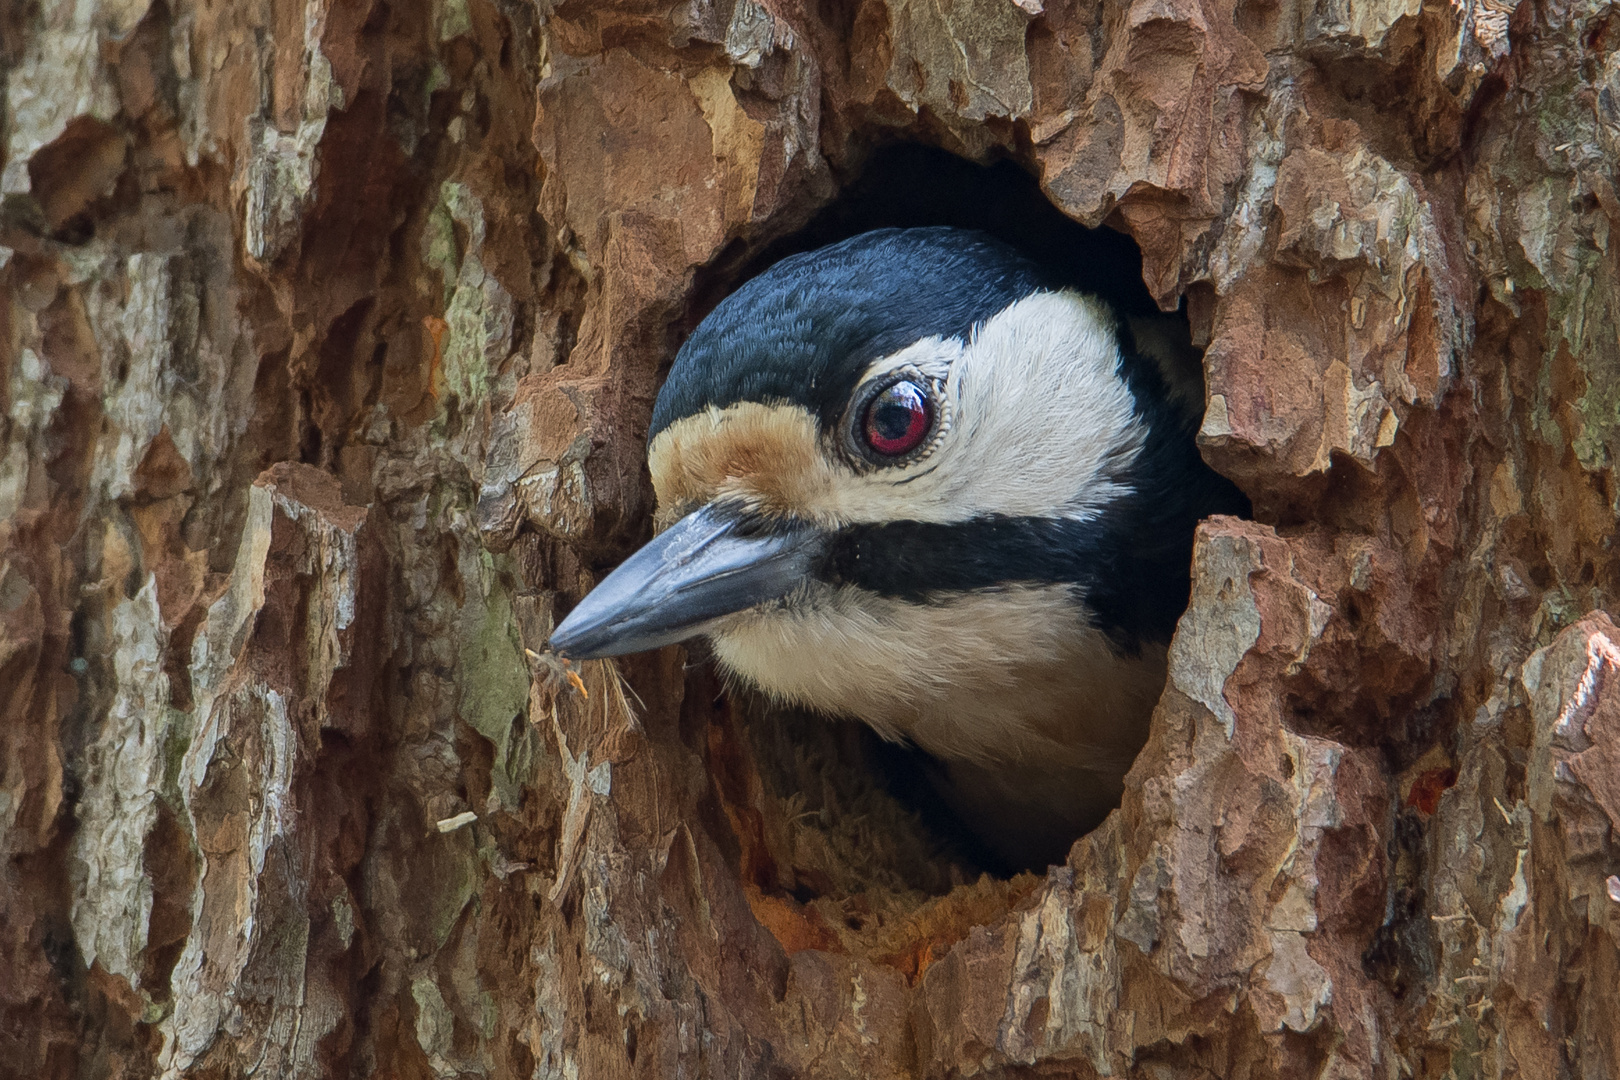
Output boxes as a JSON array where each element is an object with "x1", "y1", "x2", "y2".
[{"x1": 9, "y1": 0, "x2": 1620, "y2": 1080}]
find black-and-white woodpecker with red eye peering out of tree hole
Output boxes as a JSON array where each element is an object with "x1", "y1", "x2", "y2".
[{"x1": 549, "y1": 227, "x2": 1247, "y2": 868}]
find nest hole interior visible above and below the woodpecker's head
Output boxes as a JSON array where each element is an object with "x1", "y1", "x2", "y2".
[{"x1": 682, "y1": 144, "x2": 1202, "y2": 978}]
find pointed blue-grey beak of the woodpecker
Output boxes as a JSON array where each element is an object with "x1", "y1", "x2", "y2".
[{"x1": 551, "y1": 505, "x2": 823, "y2": 661}]
